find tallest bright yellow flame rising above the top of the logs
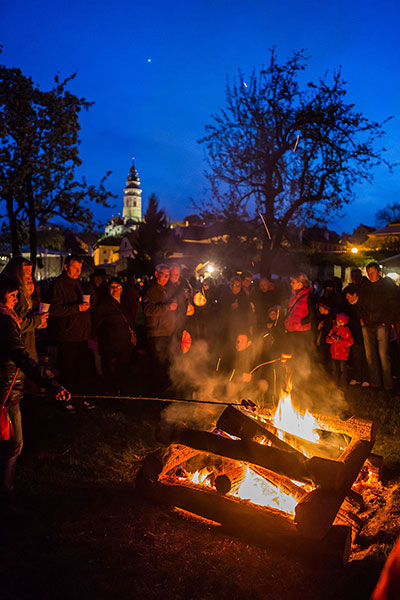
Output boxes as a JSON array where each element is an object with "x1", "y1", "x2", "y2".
[{"x1": 272, "y1": 388, "x2": 320, "y2": 443}]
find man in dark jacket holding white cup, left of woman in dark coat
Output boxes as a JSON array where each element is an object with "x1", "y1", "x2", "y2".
[{"x1": 50, "y1": 255, "x2": 93, "y2": 392}]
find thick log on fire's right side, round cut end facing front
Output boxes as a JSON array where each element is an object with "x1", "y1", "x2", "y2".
[{"x1": 295, "y1": 440, "x2": 373, "y2": 539}]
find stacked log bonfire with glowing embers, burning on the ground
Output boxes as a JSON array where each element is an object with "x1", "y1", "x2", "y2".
[{"x1": 136, "y1": 390, "x2": 380, "y2": 564}]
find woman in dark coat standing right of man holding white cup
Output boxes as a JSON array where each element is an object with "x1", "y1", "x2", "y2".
[{"x1": 93, "y1": 277, "x2": 134, "y2": 394}]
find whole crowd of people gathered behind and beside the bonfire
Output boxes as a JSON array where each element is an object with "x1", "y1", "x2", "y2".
[{"x1": 0, "y1": 255, "x2": 400, "y2": 510}]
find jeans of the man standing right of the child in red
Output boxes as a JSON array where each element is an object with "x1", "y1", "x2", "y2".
[{"x1": 362, "y1": 325, "x2": 393, "y2": 390}]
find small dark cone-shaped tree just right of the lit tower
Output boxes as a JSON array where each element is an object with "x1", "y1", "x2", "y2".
[{"x1": 134, "y1": 194, "x2": 174, "y2": 275}]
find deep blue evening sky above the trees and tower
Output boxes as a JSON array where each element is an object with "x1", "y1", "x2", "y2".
[{"x1": 0, "y1": 0, "x2": 400, "y2": 232}]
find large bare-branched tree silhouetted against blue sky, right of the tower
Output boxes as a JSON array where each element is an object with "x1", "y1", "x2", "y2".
[{"x1": 199, "y1": 50, "x2": 393, "y2": 271}]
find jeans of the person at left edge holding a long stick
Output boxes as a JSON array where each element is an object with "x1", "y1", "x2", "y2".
[{"x1": 0, "y1": 404, "x2": 23, "y2": 492}]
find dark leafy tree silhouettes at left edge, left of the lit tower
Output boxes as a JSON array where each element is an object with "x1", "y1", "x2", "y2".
[{"x1": 0, "y1": 59, "x2": 115, "y2": 260}]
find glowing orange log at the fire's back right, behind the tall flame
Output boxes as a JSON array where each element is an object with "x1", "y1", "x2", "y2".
[{"x1": 262, "y1": 409, "x2": 377, "y2": 442}]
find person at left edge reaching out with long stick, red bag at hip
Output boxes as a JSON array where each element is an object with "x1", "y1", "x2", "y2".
[{"x1": 0, "y1": 275, "x2": 70, "y2": 504}]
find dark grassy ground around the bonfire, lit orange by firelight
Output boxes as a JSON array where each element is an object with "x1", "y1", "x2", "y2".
[{"x1": 0, "y1": 390, "x2": 400, "y2": 600}]
